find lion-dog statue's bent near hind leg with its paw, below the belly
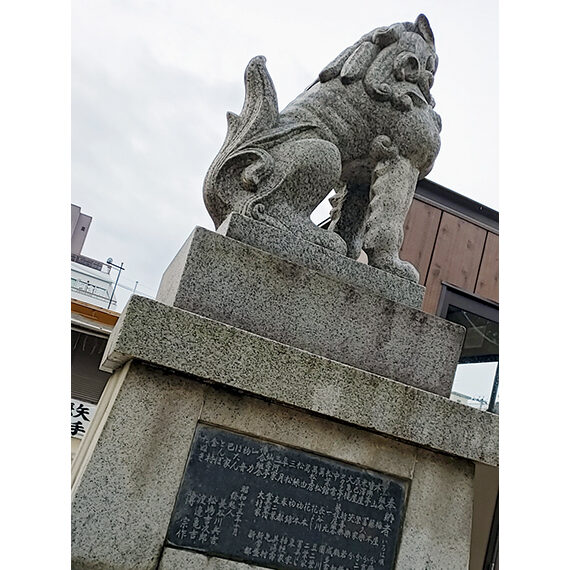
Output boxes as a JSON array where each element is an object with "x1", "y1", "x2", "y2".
[{"x1": 244, "y1": 139, "x2": 346, "y2": 255}]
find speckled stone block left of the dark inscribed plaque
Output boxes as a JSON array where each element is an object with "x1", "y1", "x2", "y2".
[{"x1": 71, "y1": 365, "x2": 204, "y2": 570}]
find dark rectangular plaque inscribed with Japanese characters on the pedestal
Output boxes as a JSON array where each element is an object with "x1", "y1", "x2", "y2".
[{"x1": 167, "y1": 425, "x2": 407, "y2": 570}]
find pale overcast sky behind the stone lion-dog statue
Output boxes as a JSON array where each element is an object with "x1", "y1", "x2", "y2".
[{"x1": 71, "y1": 0, "x2": 498, "y2": 306}]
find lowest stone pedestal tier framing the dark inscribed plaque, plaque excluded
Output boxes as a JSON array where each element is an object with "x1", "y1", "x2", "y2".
[{"x1": 71, "y1": 362, "x2": 484, "y2": 570}]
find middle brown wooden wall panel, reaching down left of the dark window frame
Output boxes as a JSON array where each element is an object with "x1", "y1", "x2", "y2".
[{"x1": 423, "y1": 212, "x2": 487, "y2": 314}]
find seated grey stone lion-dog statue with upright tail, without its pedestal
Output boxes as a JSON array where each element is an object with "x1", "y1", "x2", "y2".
[{"x1": 204, "y1": 15, "x2": 441, "y2": 281}]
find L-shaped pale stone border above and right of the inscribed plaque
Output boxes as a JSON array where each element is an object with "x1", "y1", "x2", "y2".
[{"x1": 197, "y1": 387, "x2": 473, "y2": 570}]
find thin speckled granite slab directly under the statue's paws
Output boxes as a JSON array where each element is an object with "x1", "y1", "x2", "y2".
[{"x1": 218, "y1": 212, "x2": 425, "y2": 309}]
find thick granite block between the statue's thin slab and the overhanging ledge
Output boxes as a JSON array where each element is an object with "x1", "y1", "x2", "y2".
[{"x1": 157, "y1": 228, "x2": 465, "y2": 396}]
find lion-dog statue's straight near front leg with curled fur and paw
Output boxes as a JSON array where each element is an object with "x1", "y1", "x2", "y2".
[{"x1": 363, "y1": 137, "x2": 419, "y2": 283}]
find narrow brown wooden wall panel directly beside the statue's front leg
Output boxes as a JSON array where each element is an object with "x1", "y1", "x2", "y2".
[{"x1": 400, "y1": 199, "x2": 441, "y2": 285}]
